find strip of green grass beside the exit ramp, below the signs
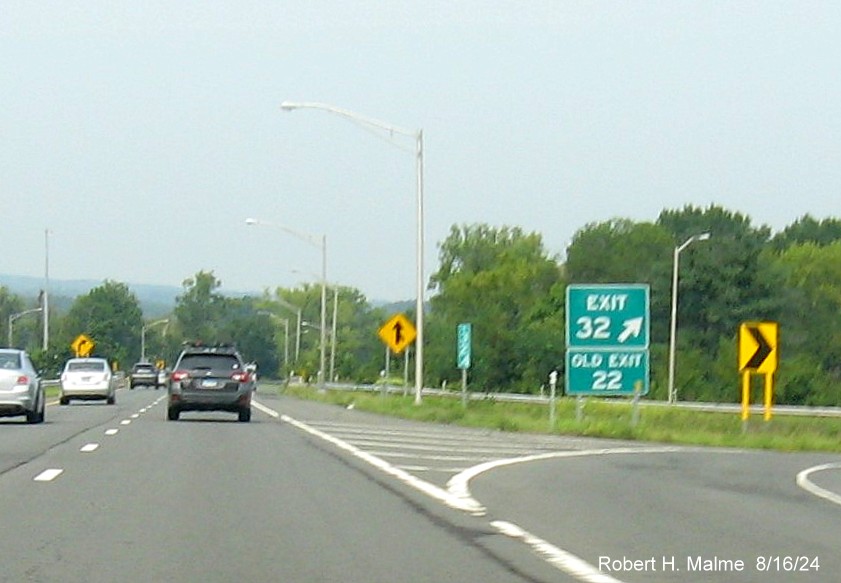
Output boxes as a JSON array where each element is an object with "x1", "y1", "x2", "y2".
[{"x1": 276, "y1": 386, "x2": 841, "y2": 452}]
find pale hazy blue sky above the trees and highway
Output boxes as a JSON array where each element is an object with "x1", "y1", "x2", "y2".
[{"x1": 0, "y1": 0, "x2": 841, "y2": 301}]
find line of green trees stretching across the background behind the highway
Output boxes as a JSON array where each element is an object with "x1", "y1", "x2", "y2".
[{"x1": 0, "y1": 205, "x2": 841, "y2": 405}]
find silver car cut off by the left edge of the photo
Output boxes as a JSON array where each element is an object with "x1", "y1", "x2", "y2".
[{"x1": 0, "y1": 348, "x2": 47, "y2": 423}]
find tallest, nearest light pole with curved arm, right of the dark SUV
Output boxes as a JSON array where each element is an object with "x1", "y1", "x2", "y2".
[{"x1": 280, "y1": 101, "x2": 424, "y2": 405}]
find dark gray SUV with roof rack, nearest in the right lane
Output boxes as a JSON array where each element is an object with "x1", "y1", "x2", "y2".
[{"x1": 167, "y1": 344, "x2": 254, "y2": 422}]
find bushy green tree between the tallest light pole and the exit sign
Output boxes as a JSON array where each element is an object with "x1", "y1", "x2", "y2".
[{"x1": 427, "y1": 225, "x2": 563, "y2": 391}]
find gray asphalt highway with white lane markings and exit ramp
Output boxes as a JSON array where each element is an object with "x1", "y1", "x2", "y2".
[{"x1": 0, "y1": 390, "x2": 841, "y2": 583}]
